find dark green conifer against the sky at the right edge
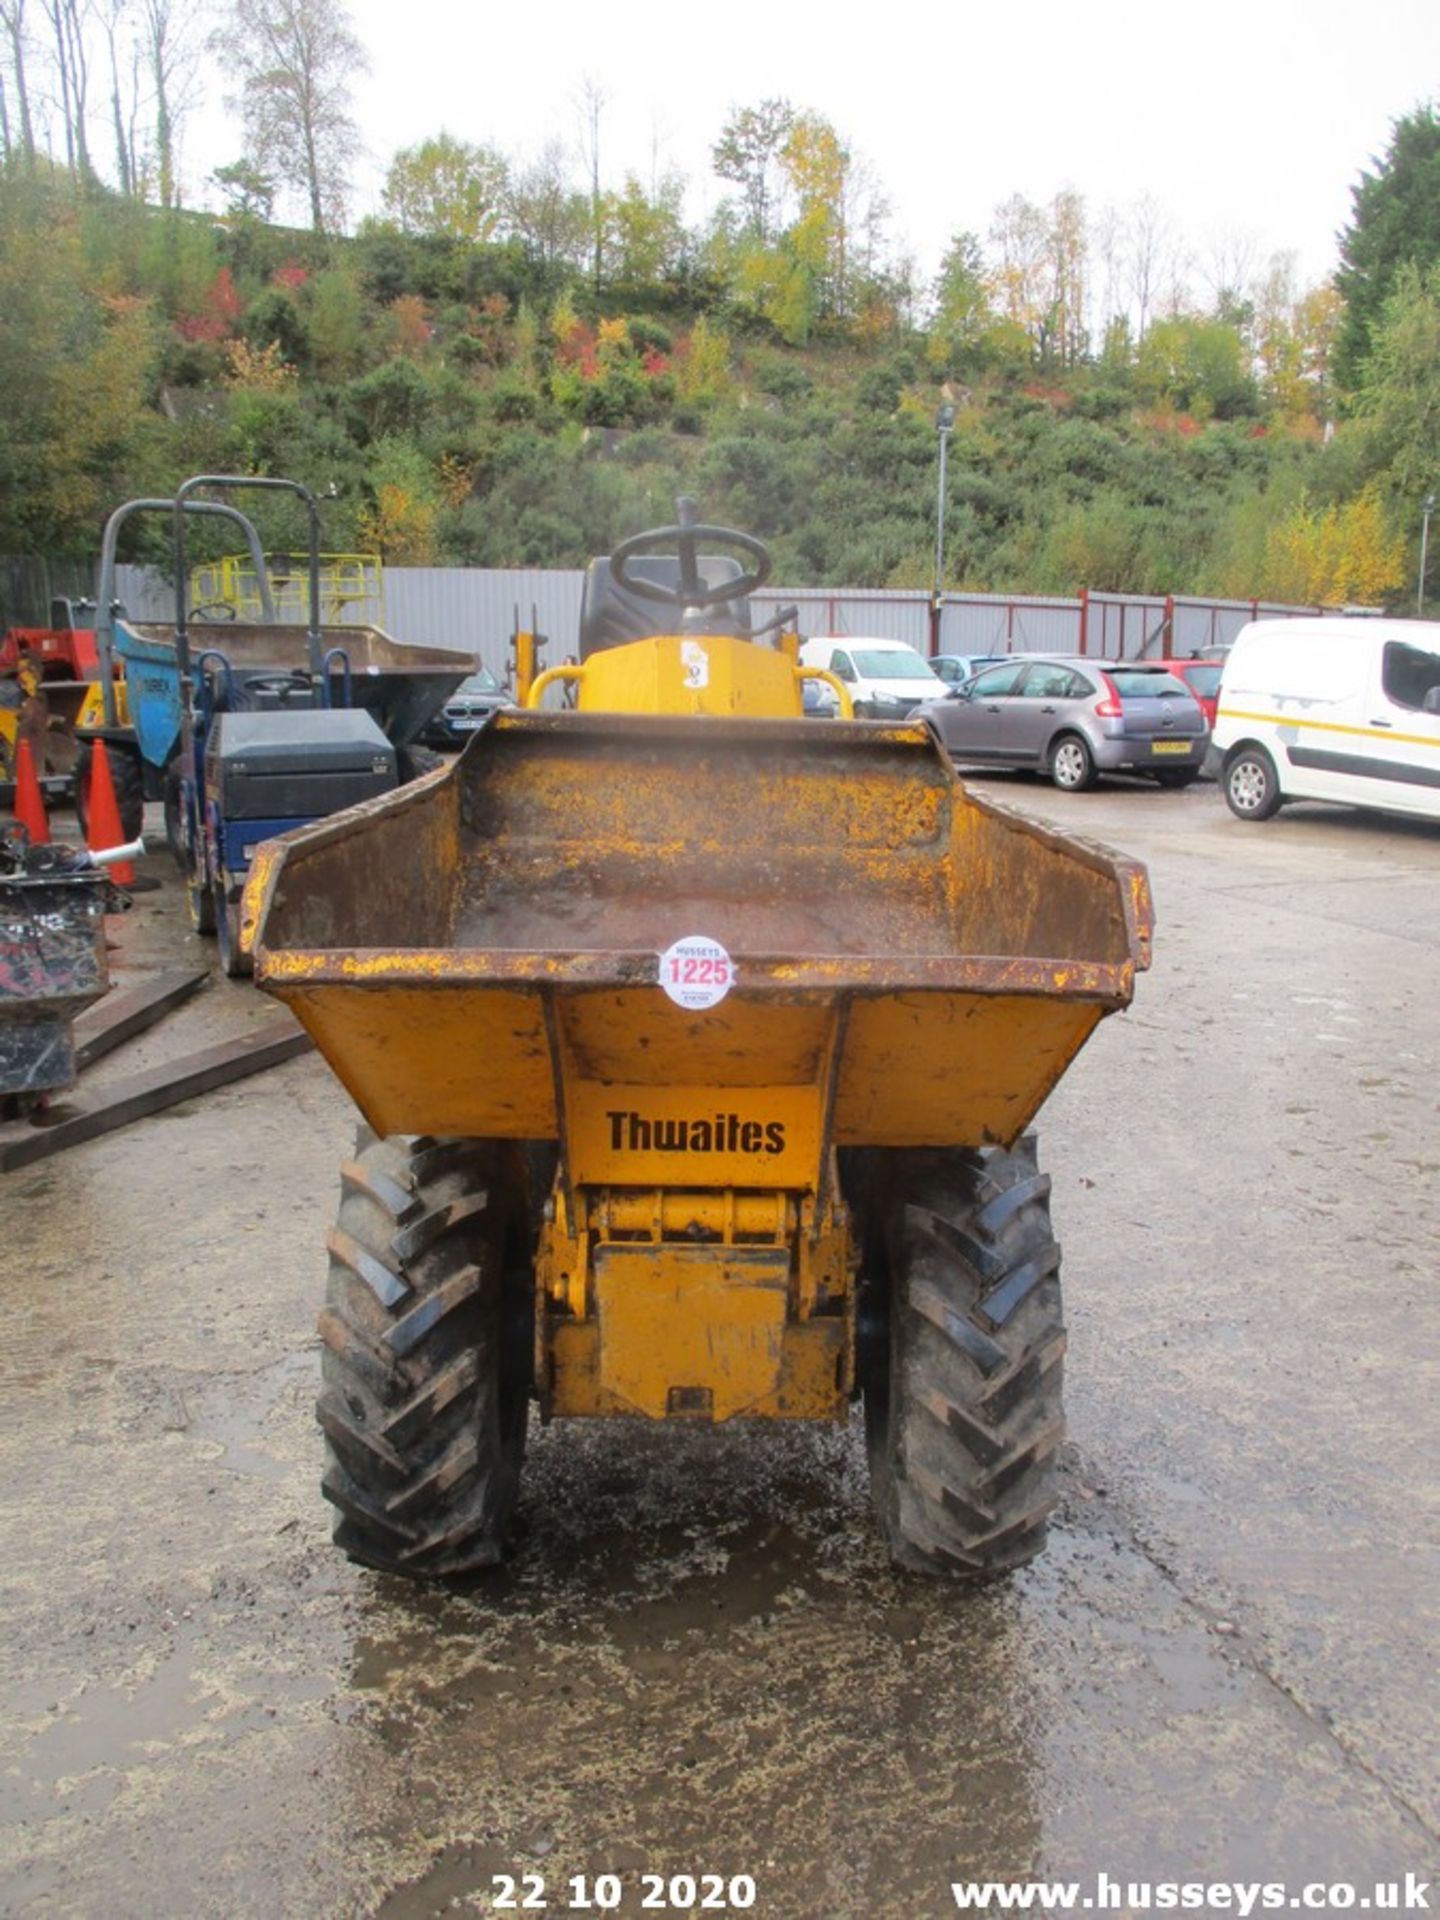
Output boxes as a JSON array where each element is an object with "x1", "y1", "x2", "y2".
[{"x1": 1334, "y1": 106, "x2": 1440, "y2": 390}]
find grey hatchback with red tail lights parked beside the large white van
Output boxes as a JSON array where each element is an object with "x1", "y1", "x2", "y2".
[{"x1": 916, "y1": 655, "x2": 1210, "y2": 793}]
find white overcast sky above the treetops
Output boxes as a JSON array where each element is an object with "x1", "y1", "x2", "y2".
[{"x1": 186, "y1": 0, "x2": 1440, "y2": 284}]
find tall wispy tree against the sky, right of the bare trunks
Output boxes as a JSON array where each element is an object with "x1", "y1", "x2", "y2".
[{"x1": 224, "y1": 0, "x2": 369, "y2": 232}]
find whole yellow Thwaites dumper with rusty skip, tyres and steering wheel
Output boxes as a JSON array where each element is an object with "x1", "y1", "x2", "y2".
[{"x1": 242, "y1": 503, "x2": 1150, "y2": 1574}]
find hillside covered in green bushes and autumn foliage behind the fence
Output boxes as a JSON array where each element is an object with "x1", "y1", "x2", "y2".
[{"x1": 0, "y1": 165, "x2": 1436, "y2": 622}]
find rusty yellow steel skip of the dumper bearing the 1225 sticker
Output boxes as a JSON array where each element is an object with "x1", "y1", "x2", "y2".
[{"x1": 242, "y1": 712, "x2": 1152, "y2": 1159}]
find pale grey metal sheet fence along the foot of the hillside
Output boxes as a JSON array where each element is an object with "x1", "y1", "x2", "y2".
[{"x1": 78, "y1": 566, "x2": 1379, "y2": 680}]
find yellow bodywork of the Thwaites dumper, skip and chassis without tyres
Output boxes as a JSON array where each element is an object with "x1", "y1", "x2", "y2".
[{"x1": 244, "y1": 687, "x2": 1150, "y2": 1451}]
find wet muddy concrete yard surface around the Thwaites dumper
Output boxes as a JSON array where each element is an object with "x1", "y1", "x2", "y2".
[{"x1": 0, "y1": 780, "x2": 1440, "y2": 1920}]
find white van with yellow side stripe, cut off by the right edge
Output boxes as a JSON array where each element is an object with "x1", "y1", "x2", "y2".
[{"x1": 1206, "y1": 618, "x2": 1440, "y2": 820}]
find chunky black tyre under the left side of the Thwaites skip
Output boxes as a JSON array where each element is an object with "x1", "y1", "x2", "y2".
[{"x1": 317, "y1": 1131, "x2": 534, "y2": 1578}]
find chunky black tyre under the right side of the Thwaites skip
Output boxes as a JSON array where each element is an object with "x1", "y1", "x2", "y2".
[{"x1": 862, "y1": 1135, "x2": 1066, "y2": 1578}]
